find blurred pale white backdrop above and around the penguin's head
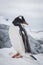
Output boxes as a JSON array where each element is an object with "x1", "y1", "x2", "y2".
[{"x1": 0, "y1": 0, "x2": 43, "y2": 31}]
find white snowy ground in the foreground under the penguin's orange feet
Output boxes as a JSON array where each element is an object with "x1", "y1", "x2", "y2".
[{"x1": 0, "y1": 48, "x2": 38, "y2": 65}]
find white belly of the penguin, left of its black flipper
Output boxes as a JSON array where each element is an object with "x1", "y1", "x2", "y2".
[{"x1": 9, "y1": 24, "x2": 25, "y2": 54}]
